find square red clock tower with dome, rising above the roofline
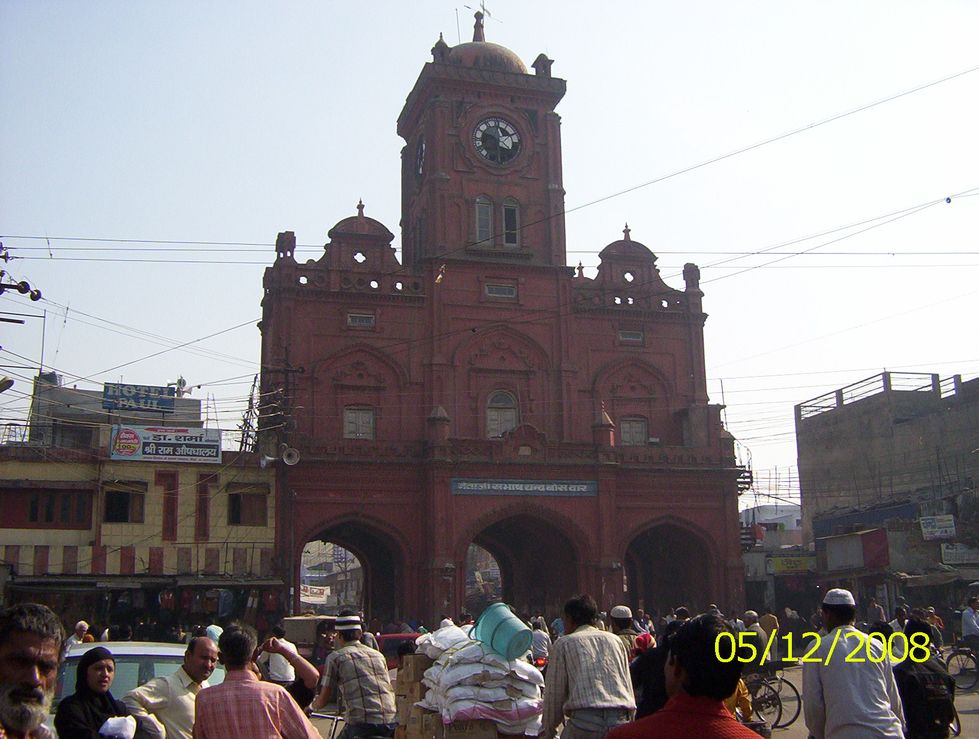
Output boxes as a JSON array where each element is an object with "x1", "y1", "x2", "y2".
[{"x1": 398, "y1": 12, "x2": 566, "y2": 268}]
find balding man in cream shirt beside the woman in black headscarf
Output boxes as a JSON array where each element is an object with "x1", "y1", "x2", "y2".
[{"x1": 122, "y1": 636, "x2": 218, "y2": 739}]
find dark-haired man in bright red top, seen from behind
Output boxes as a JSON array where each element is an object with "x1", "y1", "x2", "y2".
[{"x1": 605, "y1": 614, "x2": 758, "y2": 739}]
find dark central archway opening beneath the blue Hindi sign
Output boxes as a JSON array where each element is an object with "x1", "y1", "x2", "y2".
[{"x1": 461, "y1": 509, "x2": 582, "y2": 618}]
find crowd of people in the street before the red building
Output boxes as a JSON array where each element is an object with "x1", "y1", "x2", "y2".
[{"x1": 0, "y1": 589, "x2": 964, "y2": 739}]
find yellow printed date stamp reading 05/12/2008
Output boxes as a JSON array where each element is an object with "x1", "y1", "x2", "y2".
[{"x1": 714, "y1": 629, "x2": 932, "y2": 665}]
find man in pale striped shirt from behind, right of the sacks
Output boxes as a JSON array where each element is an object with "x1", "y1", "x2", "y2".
[{"x1": 540, "y1": 595, "x2": 636, "y2": 739}]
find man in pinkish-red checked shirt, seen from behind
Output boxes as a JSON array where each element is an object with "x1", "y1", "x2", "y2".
[{"x1": 194, "y1": 626, "x2": 321, "y2": 739}]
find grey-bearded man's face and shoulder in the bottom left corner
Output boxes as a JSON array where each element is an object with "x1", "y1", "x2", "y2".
[{"x1": 0, "y1": 603, "x2": 65, "y2": 739}]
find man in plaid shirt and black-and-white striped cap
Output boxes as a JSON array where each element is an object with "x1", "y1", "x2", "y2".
[{"x1": 309, "y1": 616, "x2": 398, "y2": 739}]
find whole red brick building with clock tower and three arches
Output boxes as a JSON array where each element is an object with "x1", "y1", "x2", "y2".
[{"x1": 261, "y1": 16, "x2": 744, "y2": 618}]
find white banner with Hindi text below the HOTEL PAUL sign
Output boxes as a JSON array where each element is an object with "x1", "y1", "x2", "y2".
[{"x1": 109, "y1": 424, "x2": 221, "y2": 464}]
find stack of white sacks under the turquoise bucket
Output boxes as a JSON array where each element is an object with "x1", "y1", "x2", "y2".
[{"x1": 418, "y1": 626, "x2": 544, "y2": 736}]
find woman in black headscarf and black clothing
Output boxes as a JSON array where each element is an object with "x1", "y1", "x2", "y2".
[{"x1": 54, "y1": 647, "x2": 129, "y2": 739}]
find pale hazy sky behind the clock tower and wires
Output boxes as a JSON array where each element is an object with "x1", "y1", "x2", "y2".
[{"x1": 0, "y1": 0, "x2": 979, "y2": 507}]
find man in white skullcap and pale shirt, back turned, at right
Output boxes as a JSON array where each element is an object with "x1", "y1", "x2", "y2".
[{"x1": 802, "y1": 588, "x2": 904, "y2": 739}]
